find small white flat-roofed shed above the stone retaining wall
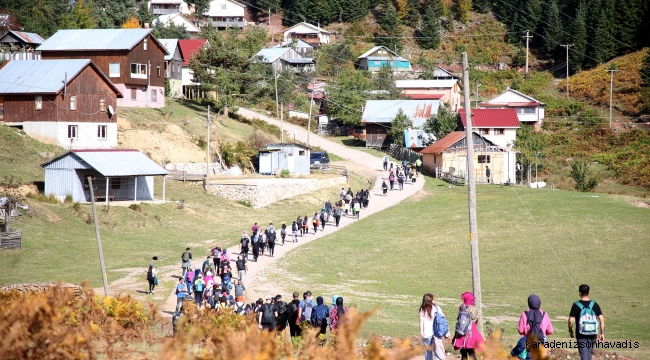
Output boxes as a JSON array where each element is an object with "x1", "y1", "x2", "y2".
[{"x1": 258, "y1": 144, "x2": 310, "y2": 175}]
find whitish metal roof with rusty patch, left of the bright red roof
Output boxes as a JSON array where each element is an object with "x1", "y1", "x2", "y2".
[{"x1": 361, "y1": 100, "x2": 440, "y2": 127}]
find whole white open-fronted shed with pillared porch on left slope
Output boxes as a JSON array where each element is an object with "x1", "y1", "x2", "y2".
[{"x1": 41, "y1": 149, "x2": 168, "y2": 202}]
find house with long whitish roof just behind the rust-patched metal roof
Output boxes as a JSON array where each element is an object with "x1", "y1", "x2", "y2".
[{"x1": 395, "y1": 79, "x2": 460, "y2": 112}]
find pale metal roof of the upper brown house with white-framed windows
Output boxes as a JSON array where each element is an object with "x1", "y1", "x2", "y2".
[{"x1": 36, "y1": 29, "x2": 166, "y2": 51}]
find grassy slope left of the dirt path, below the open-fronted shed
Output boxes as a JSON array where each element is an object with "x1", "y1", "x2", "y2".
[{"x1": 0, "y1": 174, "x2": 366, "y2": 291}]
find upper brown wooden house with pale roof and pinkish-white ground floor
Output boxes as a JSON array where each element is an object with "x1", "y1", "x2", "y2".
[{"x1": 37, "y1": 29, "x2": 168, "y2": 108}]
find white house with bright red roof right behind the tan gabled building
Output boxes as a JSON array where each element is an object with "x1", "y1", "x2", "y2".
[{"x1": 458, "y1": 109, "x2": 519, "y2": 149}]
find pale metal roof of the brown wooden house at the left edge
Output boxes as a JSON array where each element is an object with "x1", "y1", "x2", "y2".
[{"x1": 0, "y1": 59, "x2": 122, "y2": 97}]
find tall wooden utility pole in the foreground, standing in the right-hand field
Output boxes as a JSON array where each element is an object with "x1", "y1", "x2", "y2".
[{"x1": 462, "y1": 52, "x2": 484, "y2": 332}]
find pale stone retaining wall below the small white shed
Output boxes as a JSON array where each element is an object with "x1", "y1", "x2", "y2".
[{"x1": 208, "y1": 176, "x2": 346, "y2": 208}]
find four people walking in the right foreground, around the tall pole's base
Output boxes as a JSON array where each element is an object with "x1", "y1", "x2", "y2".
[{"x1": 418, "y1": 284, "x2": 605, "y2": 360}]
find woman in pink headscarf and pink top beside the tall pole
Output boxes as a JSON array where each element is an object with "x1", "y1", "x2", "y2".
[{"x1": 452, "y1": 292, "x2": 485, "y2": 360}]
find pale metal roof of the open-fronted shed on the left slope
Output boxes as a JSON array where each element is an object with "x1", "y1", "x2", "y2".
[{"x1": 41, "y1": 149, "x2": 168, "y2": 177}]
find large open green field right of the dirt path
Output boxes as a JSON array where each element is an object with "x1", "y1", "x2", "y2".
[{"x1": 263, "y1": 178, "x2": 650, "y2": 358}]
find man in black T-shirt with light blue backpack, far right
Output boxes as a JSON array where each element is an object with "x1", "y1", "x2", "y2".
[{"x1": 569, "y1": 284, "x2": 605, "y2": 360}]
